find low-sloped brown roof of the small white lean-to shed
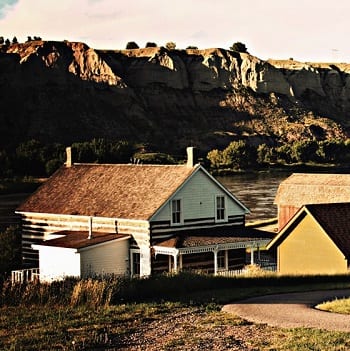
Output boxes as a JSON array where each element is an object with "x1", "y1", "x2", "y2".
[{"x1": 36, "y1": 230, "x2": 130, "y2": 249}]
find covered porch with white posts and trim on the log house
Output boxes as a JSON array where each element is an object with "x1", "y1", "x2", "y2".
[{"x1": 152, "y1": 231, "x2": 276, "y2": 276}]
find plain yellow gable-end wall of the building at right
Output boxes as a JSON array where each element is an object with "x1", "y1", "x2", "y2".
[{"x1": 278, "y1": 214, "x2": 347, "y2": 274}]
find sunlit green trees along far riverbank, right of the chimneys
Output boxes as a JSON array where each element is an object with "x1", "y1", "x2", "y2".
[{"x1": 207, "y1": 140, "x2": 350, "y2": 170}]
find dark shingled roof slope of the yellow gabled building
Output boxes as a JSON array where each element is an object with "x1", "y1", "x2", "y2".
[{"x1": 305, "y1": 203, "x2": 350, "y2": 258}]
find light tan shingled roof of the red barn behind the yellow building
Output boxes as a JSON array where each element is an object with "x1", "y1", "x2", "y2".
[{"x1": 275, "y1": 173, "x2": 350, "y2": 207}]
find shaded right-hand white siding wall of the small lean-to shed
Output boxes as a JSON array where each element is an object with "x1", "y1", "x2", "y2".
[{"x1": 80, "y1": 240, "x2": 129, "y2": 278}]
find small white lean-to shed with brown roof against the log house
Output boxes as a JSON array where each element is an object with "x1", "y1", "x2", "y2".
[{"x1": 32, "y1": 231, "x2": 130, "y2": 282}]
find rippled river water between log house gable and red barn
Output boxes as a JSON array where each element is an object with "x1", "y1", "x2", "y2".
[{"x1": 216, "y1": 173, "x2": 290, "y2": 221}]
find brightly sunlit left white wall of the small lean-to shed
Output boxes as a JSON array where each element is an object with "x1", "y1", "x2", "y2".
[{"x1": 36, "y1": 246, "x2": 80, "y2": 282}]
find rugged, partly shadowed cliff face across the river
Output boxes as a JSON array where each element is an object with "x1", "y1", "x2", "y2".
[{"x1": 0, "y1": 41, "x2": 350, "y2": 152}]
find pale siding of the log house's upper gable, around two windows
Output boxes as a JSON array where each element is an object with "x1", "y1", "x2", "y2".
[{"x1": 152, "y1": 171, "x2": 245, "y2": 221}]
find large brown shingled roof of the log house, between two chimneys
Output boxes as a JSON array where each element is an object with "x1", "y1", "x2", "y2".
[{"x1": 17, "y1": 164, "x2": 199, "y2": 220}]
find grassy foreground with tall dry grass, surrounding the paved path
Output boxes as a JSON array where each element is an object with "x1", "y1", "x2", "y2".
[{"x1": 0, "y1": 274, "x2": 350, "y2": 351}]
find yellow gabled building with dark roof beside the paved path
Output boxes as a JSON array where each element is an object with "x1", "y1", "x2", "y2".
[{"x1": 267, "y1": 203, "x2": 350, "y2": 274}]
